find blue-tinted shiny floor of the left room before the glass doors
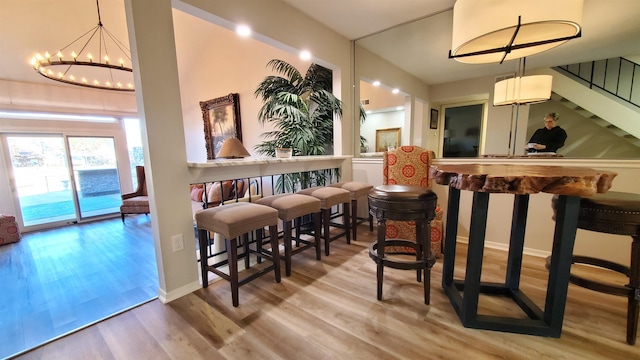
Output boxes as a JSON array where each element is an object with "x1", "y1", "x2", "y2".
[{"x1": 0, "y1": 215, "x2": 158, "y2": 359}]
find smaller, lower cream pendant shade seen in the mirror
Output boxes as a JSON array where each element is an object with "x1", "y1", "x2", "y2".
[{"x1": 493, "y1": 75, "x2": 553, "y2": 106}]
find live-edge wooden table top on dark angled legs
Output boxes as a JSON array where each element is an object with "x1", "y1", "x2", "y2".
[{"x1": 430, "y1": 164, "x2": 618, "y2": 196}]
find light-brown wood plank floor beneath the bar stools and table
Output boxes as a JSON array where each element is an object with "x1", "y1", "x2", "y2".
[{"x1": 11, "y1": 222, "x2": 640, "y2": 359}]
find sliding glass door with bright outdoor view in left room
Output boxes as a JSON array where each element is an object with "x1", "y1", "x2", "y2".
[{"x1": 5, "y1": 134, "x2": 121, "y2": 227}]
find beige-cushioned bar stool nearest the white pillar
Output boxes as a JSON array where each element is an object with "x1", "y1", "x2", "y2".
[{"x1": 195, "y1": 202, "x2": 280, "y2": 307}]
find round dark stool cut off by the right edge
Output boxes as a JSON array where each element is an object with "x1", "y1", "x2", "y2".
[{"x1": 547, "y1": 191, "x2": 640, "y2": 345}]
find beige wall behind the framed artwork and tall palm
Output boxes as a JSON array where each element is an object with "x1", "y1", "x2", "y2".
[{"x1": 173, "y1": 10, "x2": 312, "y2": 161}]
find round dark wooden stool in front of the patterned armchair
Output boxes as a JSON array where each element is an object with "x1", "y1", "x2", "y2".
[{"x1": 368, "y1": 185, "x2": 438, "y2": 305}]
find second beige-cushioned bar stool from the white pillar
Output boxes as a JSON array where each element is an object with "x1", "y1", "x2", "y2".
[{"x1": 256, "y1": 194, "x2": 322, "y2": 276}]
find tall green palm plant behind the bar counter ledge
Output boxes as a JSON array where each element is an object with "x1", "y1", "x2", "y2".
[{"x1": 254, "y1": 59, "x2": 342, "y2": 190}]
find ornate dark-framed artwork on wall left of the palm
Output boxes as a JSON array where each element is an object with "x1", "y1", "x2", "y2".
[{"x1": 200, "y1": 93, "x2": 242, "y2": 160}]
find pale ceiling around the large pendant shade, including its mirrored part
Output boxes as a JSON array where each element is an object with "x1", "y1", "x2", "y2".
[{"x1": 283, "y1": 0, "x2": 640, "y2": 84}]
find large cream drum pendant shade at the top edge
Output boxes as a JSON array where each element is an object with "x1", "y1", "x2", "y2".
[{"x1": 449, "y1": 0, "x2": 583, "y2": 64}]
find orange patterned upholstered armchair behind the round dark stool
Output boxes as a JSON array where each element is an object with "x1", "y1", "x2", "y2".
[{"x1": 382, "y1": 146, "x2": 443, "y2": 257}]
